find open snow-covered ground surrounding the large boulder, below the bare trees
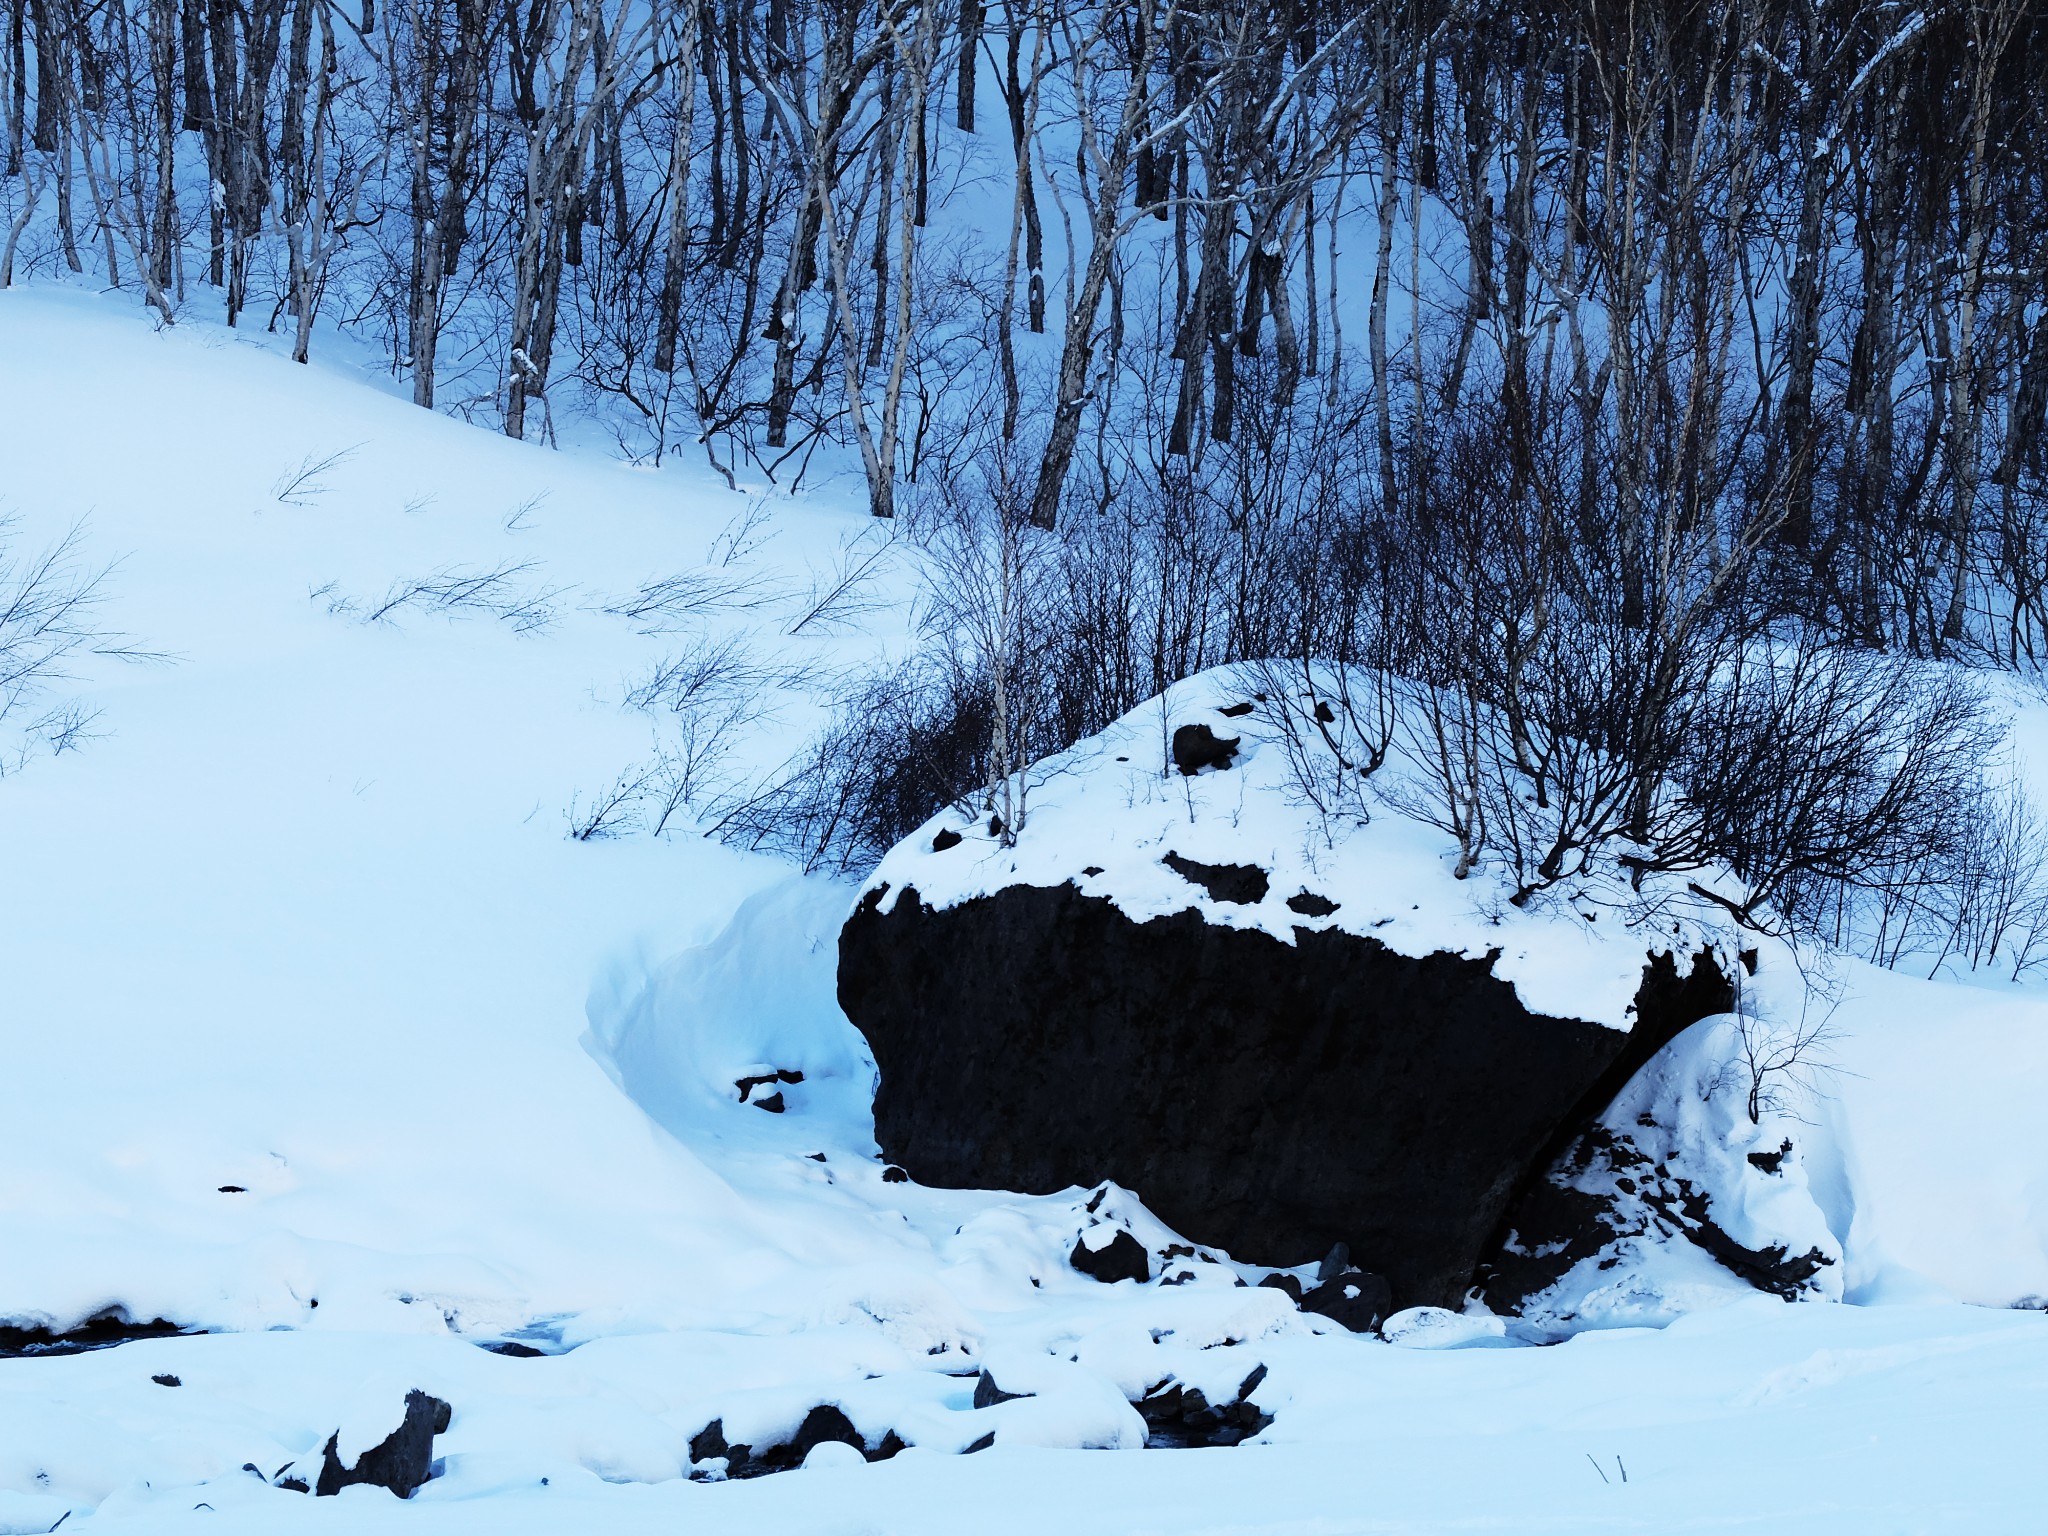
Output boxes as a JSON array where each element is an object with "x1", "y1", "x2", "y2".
[{"x1": 0, "y1": 289, "x2": 2048, "y2": 1536}]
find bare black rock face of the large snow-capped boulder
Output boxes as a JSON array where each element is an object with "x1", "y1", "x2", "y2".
[{"x1": 840, "y1": 885, "x2": 1731, "y2": 1307}]
